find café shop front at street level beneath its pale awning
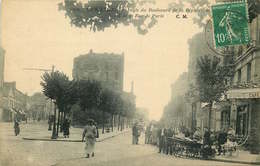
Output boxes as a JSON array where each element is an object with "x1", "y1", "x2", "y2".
[{"x1": 227, "y1": 88, "x2": 260, "y2": 153}]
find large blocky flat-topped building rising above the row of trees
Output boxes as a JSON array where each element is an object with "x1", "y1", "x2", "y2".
[{"x1": 72, "y1": 50, "x2": 124, "y2": 91}]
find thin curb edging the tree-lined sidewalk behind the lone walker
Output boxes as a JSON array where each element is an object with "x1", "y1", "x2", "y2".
[{"x1": 23, "y1": 131, "x2": 129, "y2": 142}]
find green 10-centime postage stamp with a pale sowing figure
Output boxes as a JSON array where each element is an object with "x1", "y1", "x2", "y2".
[{"x1": 211, "y1": 2, "x2": 250, "y2": 47}]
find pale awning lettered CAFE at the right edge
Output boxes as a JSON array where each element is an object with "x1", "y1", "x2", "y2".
[{"x1": 227, "y1": 88, "x2": 260, "y2": 99}]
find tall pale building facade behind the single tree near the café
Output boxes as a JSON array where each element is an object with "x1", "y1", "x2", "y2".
[{"x1": 187, "y1": 32, "x2": 220, "y2": 130}]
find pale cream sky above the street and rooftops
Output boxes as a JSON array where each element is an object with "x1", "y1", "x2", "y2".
[{"x1": 1, "y1": 0, "x2": 206, "y2": 120}]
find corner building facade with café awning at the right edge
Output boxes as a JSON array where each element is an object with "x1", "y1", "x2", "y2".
[{"x1": 225, "y1": 15, "x2": 260, "y2": 151}]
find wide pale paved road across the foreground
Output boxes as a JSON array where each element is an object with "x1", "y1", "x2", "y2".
[{"x1": 0, "y1": 123, "x2": 252, "y2": 166}]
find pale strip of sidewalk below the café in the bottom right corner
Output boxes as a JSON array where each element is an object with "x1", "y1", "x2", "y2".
[{"x1": 211, "y1": 150, "x2": 260, "y2": 165}]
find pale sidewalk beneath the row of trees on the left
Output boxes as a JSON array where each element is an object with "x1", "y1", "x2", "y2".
[{"x1": 23, "y1": 123, "x2": 130, "y2": 142}]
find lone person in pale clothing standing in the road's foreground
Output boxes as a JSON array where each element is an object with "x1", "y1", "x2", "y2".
[{"x1": 82, "y1": 119, "x2": 97, "y2": 158}]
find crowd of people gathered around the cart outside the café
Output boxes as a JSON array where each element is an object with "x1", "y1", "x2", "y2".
[{"x1": 142, "y1": 123, "x2": 237, "y2": 158}]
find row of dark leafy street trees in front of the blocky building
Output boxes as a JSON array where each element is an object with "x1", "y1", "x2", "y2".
[{"x1": 40, "y1": 71, "x2": 135, "y2": 138}]
